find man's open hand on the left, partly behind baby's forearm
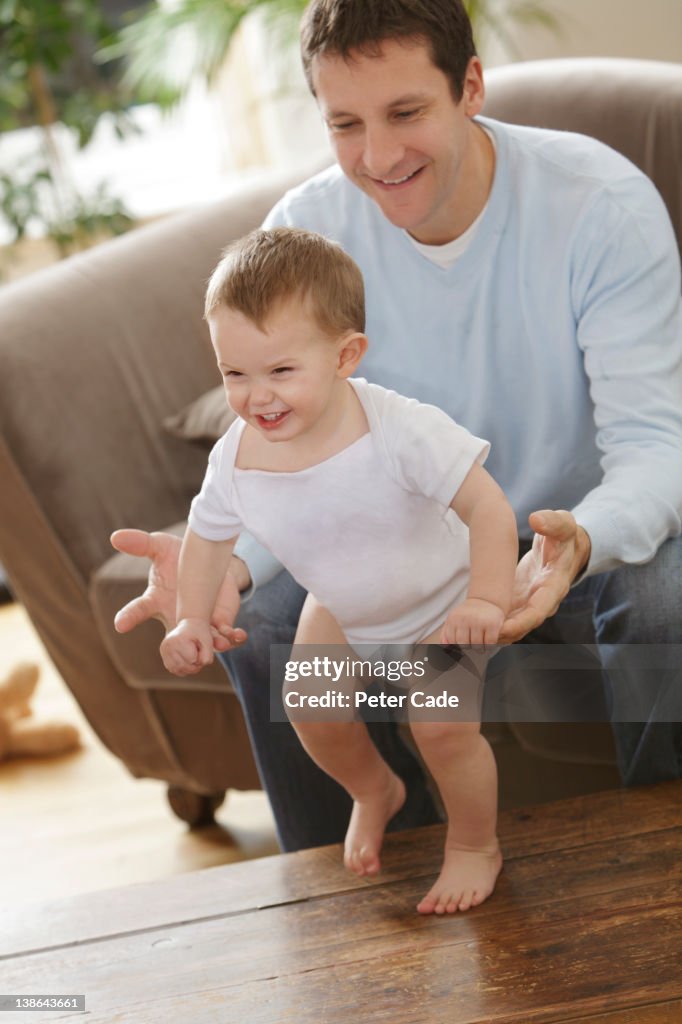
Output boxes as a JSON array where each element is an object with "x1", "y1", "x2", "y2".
[{"x1": 111, "y1": 529, "x2": 251, "y2": 651}]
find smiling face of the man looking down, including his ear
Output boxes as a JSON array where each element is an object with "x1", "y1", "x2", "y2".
[{"x1": 312, "y1": 39, "x2": 485, "y2": 245}]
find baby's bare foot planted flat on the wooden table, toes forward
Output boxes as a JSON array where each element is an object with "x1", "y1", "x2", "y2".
[{"x1": 417, "y1": 840, "x2": 502, "y2": 913}]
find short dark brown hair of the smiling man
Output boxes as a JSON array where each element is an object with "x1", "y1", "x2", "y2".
[{"x1": 301, "y1": 0, "x2": 476, "y2": 102}]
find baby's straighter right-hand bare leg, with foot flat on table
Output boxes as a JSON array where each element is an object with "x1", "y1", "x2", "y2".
[{"x1": 411, "y1": 634, "x2": 502, "y2": 913}]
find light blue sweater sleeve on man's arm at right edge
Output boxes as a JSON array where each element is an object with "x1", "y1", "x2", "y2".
[{"x1": 572, "y1": 178, "x2": 682, "y2": 574}]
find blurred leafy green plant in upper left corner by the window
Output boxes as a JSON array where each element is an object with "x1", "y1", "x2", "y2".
[{"x1": 0, "y1": 0, "x2": 132, "y2": 268}]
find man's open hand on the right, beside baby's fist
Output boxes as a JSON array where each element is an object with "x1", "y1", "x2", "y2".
[{"x1": 500, "y1": 510, "x2": 591, "y2": 643}]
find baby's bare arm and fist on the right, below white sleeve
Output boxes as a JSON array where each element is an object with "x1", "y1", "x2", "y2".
[{"x1": 441, "y1": 463, "x2": 518, "y2": 645}]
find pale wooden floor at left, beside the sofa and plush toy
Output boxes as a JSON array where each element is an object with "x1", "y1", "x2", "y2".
[{"x1": 0, "y1": 604, "x2": 278, "y2": 906}]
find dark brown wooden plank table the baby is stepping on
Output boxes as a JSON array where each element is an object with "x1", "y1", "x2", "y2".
[{"x1": 0, "y1": 782, "x2": 682, "y2": 1024}]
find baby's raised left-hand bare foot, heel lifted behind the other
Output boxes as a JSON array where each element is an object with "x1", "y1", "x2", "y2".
[{"x1": 343, "y1": 771, "x2": 406, "y2": 874}]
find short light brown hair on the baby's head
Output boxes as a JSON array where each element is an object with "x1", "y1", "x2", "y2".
[{"x1": 204, "y1": 227, "x2": 365, "y2": 338}]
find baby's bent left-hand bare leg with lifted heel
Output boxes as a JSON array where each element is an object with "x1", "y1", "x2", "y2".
[{"x1": 285, "y1": 595, "x2": 406, "y2": 874}]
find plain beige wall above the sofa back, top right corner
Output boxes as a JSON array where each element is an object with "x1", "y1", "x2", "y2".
[{"x1": 479, "y1": 0, "x2": 682, "y2": 67}]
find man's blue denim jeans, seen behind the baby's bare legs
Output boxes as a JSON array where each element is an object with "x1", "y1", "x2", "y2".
[{"x1": 221, "y1": 539, "x2": 682, "y2": 851}]
